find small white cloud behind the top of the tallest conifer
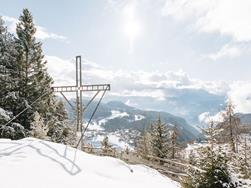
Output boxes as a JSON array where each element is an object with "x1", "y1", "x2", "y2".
[{"x1": 2, "y1": 16, "x2": 67, "y2": 41}]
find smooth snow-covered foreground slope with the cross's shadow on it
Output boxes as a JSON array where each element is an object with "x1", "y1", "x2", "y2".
[{"x1": 0, "y1": 138, "x2": 180, "y2": 188}]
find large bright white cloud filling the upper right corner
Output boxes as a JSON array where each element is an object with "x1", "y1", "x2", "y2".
[{"x1": 162, "y1": 0, "x2": 251, "y2": 42}]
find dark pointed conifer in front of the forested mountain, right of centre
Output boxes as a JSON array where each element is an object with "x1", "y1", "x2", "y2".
[{"x1": 150, "y1": 115, "x2": 170, "y2": 158}]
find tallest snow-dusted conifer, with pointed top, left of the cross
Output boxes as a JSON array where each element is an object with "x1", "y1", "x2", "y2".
[{"x1": 16, "y1": 9, "x2": 54, "y2": 130}]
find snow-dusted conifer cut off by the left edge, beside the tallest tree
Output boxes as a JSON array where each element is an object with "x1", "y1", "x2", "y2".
[{"x1": 0, "y1": 17, "x2": 26, "y2": 139}]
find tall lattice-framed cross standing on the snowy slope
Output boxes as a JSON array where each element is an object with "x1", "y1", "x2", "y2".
[{"x1": 52, "y1": 56, "x2": 111, "y2": 132}]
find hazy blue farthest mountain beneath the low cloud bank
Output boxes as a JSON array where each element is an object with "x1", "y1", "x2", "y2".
[{"x1": 109, "y1": 88, "x2": 227, "y2": 127}]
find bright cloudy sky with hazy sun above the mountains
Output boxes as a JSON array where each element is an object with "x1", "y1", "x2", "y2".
[{"x1": 0, "y1": 0, "x2": 251, "y2": 112}]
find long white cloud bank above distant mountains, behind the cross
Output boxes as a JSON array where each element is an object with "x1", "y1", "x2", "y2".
[{"x1": 45, "y1": 56, "x2": 251, "y2": 113}]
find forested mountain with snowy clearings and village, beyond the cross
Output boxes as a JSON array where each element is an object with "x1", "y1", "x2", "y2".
[{"x1": 63, "y1": 101, "x2": 199, "y2": 148}]
